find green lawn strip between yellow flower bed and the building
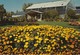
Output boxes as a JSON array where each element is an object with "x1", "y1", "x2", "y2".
[{"x1": 38, "y1": 21, "x2": 80, "y2": 31}]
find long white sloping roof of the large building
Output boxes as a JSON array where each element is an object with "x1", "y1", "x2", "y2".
[{"x1": 26, "y1": 0, "x2": 70, "y2": 9}]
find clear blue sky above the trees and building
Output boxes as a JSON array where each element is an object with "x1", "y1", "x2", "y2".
[{"x1": 0, "y1": 0, "x2": 80, "y2": 12}]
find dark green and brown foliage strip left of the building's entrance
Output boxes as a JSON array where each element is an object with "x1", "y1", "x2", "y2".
[{"x1": 0, "y1": 16, "x2": 39, "y2": 26}]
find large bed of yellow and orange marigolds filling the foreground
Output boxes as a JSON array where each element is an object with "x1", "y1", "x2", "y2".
[{"x1": 0, "y1": 25, "x2": 80, "y2": 55}]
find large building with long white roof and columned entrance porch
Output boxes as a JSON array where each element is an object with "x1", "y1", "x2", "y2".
[{"x1": 26, "y1": 0, "x2": 75, "y2": 20}]
